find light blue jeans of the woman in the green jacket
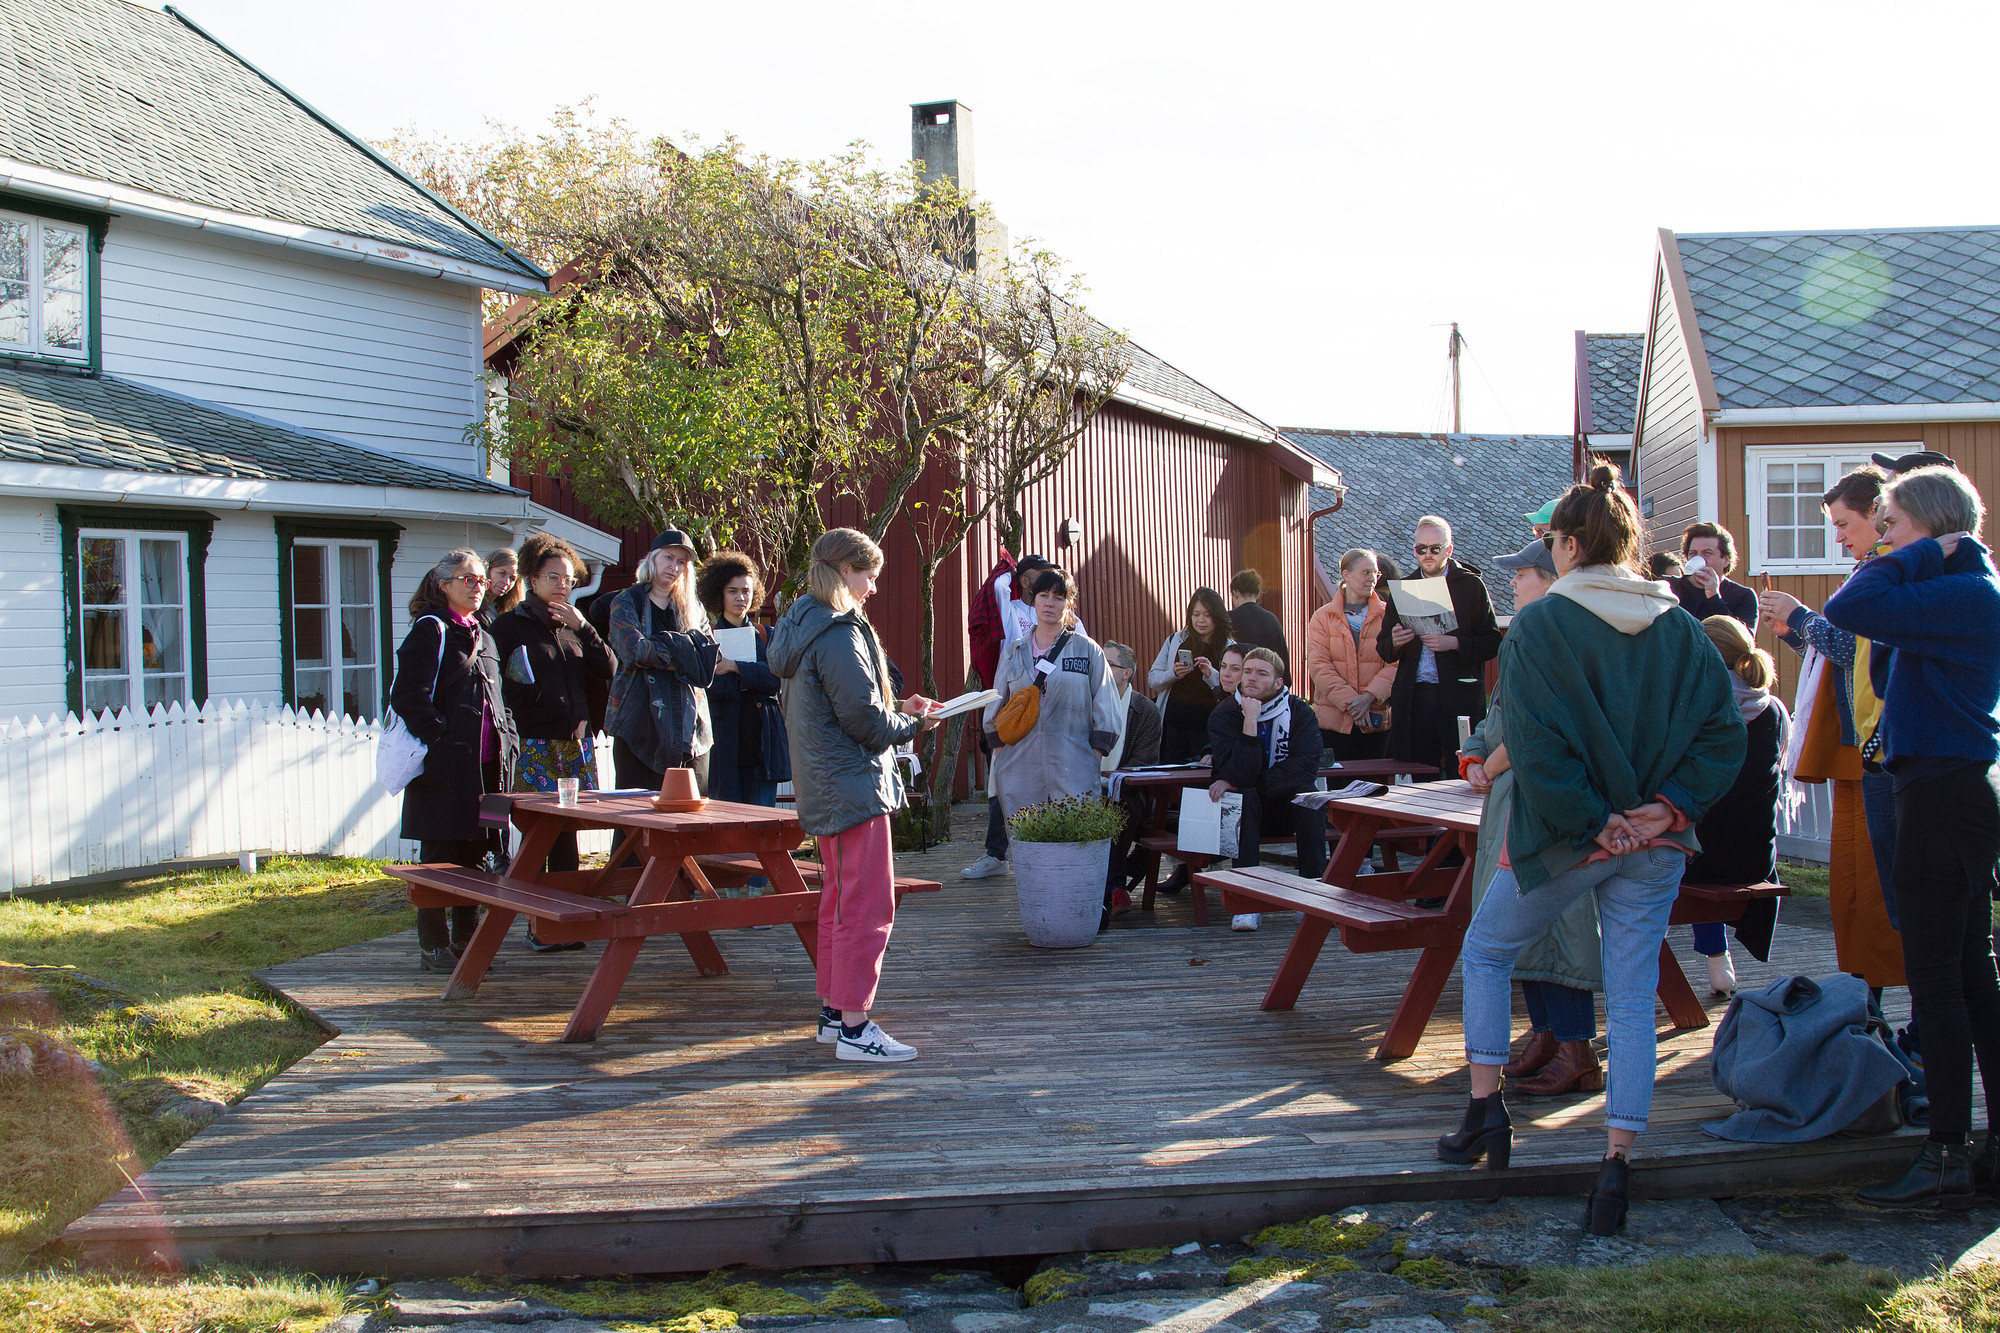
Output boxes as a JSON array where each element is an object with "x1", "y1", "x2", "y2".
[{"x1": 1464, "y1": 847, "x2": 1688, "y2": 1131}]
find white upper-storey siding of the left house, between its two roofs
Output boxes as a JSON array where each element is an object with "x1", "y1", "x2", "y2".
[{"x1": 104, "y1": 218, "x2": 484, "y2": 474}]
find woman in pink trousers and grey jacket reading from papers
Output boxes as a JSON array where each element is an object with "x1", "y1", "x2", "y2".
[{"x1": 770, "y1": 528, "x2": 936, "y2": 1065}]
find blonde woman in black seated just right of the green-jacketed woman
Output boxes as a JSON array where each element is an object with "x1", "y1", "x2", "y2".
[{"x1": 1684, "y1": 614, "x2": 1792, "y2": 995}]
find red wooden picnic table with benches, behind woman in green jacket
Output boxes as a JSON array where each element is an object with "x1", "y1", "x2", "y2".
[{"x1": 1194, "y1": 781, "x2": 1788, "y2": 1061}]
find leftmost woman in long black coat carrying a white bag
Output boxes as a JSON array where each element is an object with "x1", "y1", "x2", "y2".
[{"x1": 388, "y1": 546, "x2": 520, "y2": 973}]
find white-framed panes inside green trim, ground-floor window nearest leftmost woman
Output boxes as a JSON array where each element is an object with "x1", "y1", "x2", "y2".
[{"x1": 290, "y1": 536, "x2": 382, "y2": 719}]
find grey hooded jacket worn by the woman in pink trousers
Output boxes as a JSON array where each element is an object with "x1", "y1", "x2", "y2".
[{"x1": 770, "y1": 592, "x2": 922, "y2": 837}]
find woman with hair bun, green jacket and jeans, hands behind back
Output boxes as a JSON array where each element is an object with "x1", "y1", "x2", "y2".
[{"x1": 1438, "y1": 464, "x2": 1744, "y2": 1235}]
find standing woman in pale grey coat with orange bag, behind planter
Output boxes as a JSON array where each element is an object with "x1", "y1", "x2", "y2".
[{"x1": 986, "y1": 568, "x2": 1120, "y2": 819}]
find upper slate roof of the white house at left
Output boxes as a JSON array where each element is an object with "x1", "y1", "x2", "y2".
[{"x1": 0, "y1": 0, "x2": 546, "y2": 278}]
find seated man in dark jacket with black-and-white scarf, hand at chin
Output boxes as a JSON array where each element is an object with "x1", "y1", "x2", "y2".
[{"x1": 1208, "y1": 648, "x2": 1326, "y2": 931}]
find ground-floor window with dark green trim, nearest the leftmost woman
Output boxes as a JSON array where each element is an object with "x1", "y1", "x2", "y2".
[{"x1": 276, "y1": 518, "x2": 402, "y2": 721}]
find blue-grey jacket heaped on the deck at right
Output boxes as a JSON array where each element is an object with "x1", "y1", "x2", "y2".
[{"x1": 1702, "y1": 975, "x2": 1904, "y2": 1143}]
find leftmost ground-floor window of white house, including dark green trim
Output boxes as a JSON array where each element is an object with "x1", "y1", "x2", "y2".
[{"x1": 56, "y1": 504, "x2": 216, "y2": 713}]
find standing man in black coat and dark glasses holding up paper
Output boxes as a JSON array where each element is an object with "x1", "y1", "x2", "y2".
[{"x1": 1376, "y1": 514, "x2": 1500, "y2": 773}]
